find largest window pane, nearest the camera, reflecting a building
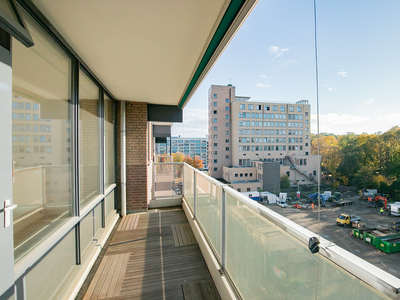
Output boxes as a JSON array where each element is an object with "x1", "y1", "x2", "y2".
[{"x1": 12, "y1": 11, "x2": 73, "y2": 261}]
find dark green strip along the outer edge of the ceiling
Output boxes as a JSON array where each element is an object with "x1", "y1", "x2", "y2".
[{"x1": 178, "y1": 0, "x2": 245, "y2": 108}]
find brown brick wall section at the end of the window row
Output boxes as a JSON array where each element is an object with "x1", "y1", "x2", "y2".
[{"x1": 117, "y1": 102, "x2": 148, "y2": 213}]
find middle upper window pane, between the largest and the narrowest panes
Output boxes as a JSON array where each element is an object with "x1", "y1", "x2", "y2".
[{"x1": 79, "y1": 71, "x2": 100, "y2": 208}]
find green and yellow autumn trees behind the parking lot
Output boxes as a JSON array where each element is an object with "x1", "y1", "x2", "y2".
[{"x1": 311, "y1": 126, "x2": 400, "y2": 200}]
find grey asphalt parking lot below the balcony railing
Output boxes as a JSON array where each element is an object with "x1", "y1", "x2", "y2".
[{"x1": 265, "y1": 196, "x2": 400, "y2": 277}]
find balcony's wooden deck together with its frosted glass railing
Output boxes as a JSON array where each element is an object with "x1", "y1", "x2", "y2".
[{"x1": 79, "y1": 163, "x2": 400, "y2": 299}]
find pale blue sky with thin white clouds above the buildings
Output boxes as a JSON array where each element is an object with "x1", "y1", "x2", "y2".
[{"x1": 172, "y1": 0, "x2": 400, "y2": 137}]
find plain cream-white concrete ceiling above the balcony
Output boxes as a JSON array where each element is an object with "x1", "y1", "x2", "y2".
[{"x1": 33, "y1": 0, "x2": 254, "y2": 105}]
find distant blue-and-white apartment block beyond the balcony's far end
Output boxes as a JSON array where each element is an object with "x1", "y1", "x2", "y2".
[{"x1": 156, "y1": 137, "x2": 208, "y2": 169}]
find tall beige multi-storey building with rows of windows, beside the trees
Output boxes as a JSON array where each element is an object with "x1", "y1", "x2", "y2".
[{"x1": 208, "y1": 85, "x2": 320, "y2": 188}]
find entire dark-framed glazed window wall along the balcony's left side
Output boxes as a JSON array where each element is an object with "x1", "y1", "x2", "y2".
[{"x1": 8, "y1": 0, "x2": 119, "y2": 299}]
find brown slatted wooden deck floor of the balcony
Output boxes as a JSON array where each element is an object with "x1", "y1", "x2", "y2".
[{"x1": 79, "y1": 209, "x2": 220, "y2": 300}]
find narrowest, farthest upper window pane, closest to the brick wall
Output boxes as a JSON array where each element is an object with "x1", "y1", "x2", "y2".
[{"x1": 104, "y1": 95, "x2": 115, "y2": 188}]
